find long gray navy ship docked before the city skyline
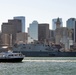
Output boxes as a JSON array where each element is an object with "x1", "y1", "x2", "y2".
[{"x1": 13, "y1": 44, "x2": 76, "y2": 57}]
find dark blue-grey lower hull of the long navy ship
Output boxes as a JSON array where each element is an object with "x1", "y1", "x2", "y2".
[{"x1": 15, "y1": 51, "x2": 76, "y2": 57}]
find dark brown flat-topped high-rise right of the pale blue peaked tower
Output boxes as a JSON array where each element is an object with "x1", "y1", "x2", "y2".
[{"x1": 38, "y1": 23, "x2": 49, "y2": 42}]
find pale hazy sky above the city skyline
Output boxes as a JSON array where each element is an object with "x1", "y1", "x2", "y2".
[{"x1": 0, "y1": 0, "x2": 76, "y2": 31}]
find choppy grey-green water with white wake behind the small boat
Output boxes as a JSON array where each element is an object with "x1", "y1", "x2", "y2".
[{"x1": 0, "y1": 57, "x2": 76, "y2": 75}]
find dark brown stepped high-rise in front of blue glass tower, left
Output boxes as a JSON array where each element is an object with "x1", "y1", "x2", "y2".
[{"x1": 1, "y1": 19, "x2": 22, "y2": 44}]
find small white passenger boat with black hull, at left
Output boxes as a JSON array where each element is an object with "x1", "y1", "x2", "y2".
[{"x1": 0, "y1": 52, "x2": 25, "y2": 62}]
